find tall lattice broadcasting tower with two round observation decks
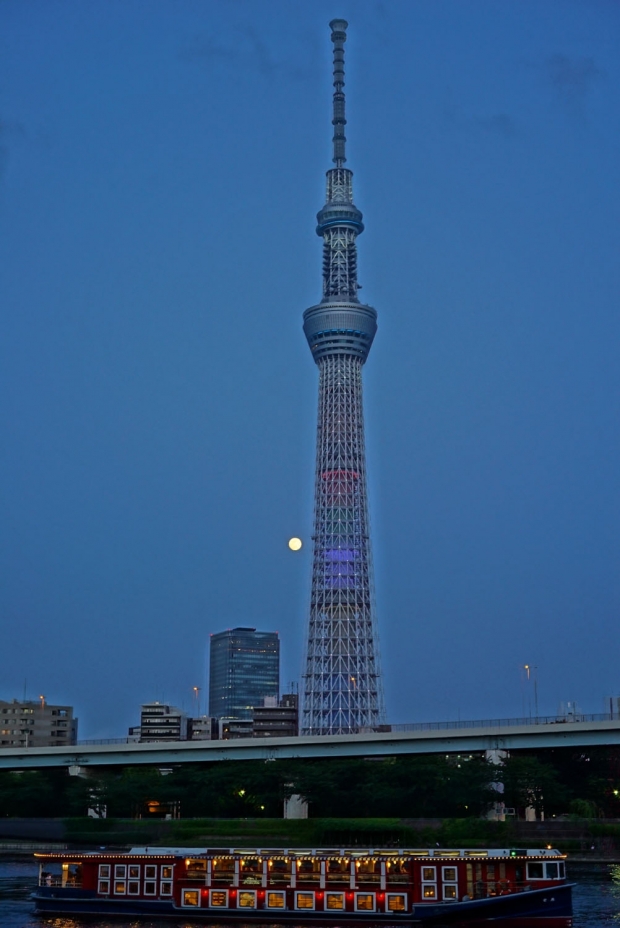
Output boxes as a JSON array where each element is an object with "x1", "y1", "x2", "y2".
[{"x1": 301, "y1": 19, "x2": 385, "y2": 735}]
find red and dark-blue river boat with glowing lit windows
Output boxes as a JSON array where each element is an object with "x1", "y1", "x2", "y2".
[{"x1": 33, "y1": 847, "x2": 572, "y2": 928}]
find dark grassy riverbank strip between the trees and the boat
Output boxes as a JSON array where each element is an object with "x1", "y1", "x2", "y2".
[{"x1": 0, "y1": 817, "x2": 620, "y2": 862}]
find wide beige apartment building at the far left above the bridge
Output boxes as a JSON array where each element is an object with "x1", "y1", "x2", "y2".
[{"x1": 0, "y1": 696, "x2": 78, "y2": 748}]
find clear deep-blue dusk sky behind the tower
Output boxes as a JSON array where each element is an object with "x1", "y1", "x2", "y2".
[{"x1": 0, "y1": 0, "x2": 620, "y2": 738}]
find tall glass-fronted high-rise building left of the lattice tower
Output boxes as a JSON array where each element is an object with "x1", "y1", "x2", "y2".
[{"x1": 209, "y1": 628, "x2": 280, "y2": 719}]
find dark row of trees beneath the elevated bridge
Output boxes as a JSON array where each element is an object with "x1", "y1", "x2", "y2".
[{"x1": 0, "y1": 748, "x2": 620, "y2": 820}]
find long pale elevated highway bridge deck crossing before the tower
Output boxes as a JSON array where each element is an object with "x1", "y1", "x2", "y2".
[{"x1": 0, "y1": 714, "x2": 620, "y2": 770}]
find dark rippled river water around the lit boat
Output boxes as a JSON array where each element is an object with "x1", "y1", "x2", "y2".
[{"x1": 0, "y1": 857, "x2": 620, "y2": 928}]
